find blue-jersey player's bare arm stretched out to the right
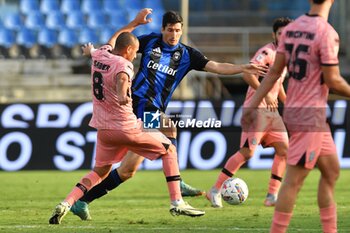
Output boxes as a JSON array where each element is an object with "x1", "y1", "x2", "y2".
[{"x1": 204, "y1": 61, "x2": 268, "y2": 75}]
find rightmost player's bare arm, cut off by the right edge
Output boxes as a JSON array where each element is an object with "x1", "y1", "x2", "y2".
[{"x1": 322, "y1": 65, "x2": 350, "y2": 97}]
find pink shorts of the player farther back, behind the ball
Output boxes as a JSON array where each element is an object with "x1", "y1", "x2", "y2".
[{"x1": 240, "y1": 112, "x2": 288, "y2": 150}]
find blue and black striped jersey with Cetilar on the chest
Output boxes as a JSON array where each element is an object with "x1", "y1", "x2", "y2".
[{"x1": 132, "y1": 33, "x2": 209, "y2": 115}]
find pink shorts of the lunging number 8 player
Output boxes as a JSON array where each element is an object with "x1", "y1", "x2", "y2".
[{"x1": 95, "y1": 125, "x2": 171, "y2": 167}]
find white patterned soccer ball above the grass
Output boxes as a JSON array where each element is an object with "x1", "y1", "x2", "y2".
[{"x1": 221, "y1": 178, "x2": 249, "y2": 205}]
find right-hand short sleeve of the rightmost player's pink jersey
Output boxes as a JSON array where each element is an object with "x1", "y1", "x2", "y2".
[{"x1": 320, "y1": 26, "x2": 339, "y2": 65}]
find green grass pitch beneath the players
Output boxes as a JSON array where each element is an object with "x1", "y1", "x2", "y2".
[{"x1": 0, "y1": 169, "x2": 350, "y2": 233}]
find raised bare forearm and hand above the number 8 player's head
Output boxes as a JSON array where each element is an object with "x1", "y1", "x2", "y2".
[{"x1": 108, "y1": 8, "x2": 152, "y2": 48}]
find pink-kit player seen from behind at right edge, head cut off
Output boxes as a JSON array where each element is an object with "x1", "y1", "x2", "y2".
[{"x1": 244, "y1": 0, "x2": 350, "y2": 233}]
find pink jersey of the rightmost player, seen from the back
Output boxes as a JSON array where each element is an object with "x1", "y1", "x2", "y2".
[{"x1": 277, "y1": 14, "x2": 339, "y2": 127}]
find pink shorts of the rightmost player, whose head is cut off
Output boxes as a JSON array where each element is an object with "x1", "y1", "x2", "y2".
[{"x1": 287, "y1": 125, "x2": 337, "y2": 169}]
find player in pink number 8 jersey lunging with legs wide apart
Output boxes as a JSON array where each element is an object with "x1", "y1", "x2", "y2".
[{"x1": 49, "y1": 11, "x2": 205, "y2": 224}]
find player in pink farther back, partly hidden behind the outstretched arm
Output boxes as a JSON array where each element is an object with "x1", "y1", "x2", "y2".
[{"x1": 206, "y1": 18, "x2": 291, "y2": 208}]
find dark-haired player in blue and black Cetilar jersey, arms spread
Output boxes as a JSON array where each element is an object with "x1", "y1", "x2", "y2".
[{"x1": 71, "y1": 8, "x2": 266, "y2": 220}]
